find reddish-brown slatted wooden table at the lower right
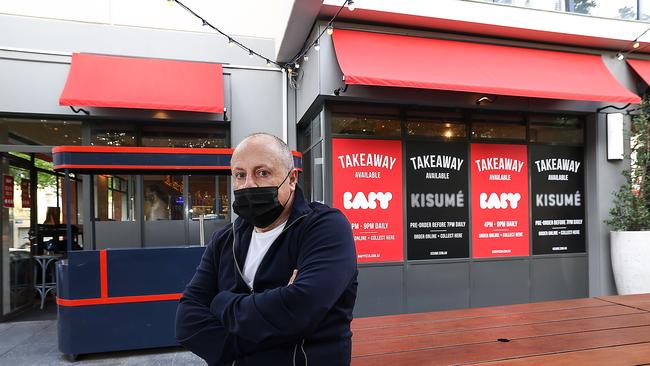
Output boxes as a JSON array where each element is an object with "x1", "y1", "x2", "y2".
[{"x1": 352, "y1": 294, "x2": 650, "y2": 366}]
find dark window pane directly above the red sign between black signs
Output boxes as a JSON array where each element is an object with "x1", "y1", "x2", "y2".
[{"x1": 471, "y1": 114, "x2": 526, "y2": 141}]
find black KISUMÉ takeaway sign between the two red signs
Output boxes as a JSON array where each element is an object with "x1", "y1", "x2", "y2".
[{"x1": 405, "y1": 141, "x2": 470, "y2": 260}]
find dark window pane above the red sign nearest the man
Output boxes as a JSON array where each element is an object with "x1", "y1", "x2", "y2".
[{"x1": 332, "y1": 114, "x2": 401, "y2": 137}]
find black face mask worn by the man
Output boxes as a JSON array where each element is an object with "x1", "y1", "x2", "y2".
[{"x1": 232, "y1": 169, "x2": 293, "y2": 229}]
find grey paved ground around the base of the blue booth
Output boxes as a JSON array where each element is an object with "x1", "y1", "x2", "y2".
[{"x1": 0, "y1": 304, "x2": 205, "y2": 366}]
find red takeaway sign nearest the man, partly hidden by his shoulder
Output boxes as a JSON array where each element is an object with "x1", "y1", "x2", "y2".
[{"x1": 332, "y1": 139, "x2": 404, "y2": 263}]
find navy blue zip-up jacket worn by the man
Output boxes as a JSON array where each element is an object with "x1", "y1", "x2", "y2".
[{"x1": 176, "y1": 186, "x2": 357, "y2": 366}]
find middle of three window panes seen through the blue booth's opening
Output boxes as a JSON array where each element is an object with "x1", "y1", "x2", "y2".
[{"x1": 143, "y1": 175, "x2": 183, "y2": 221}]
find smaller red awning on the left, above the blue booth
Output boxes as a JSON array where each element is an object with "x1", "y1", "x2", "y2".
[{"x1": 59, "y1": 53, "x2": 224, "y2": 113}]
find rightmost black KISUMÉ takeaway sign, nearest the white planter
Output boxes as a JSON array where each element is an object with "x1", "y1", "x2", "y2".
[{"x1": 530, "y1": 145, "x2": 585, "y2": 254}]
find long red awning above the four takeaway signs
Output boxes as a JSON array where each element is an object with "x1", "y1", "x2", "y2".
[{"x1": 333, "y1": 29, "x2": 640, "y2": 103}]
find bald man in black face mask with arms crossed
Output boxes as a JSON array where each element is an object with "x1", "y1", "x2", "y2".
[{"x1": 176, "y1": 133, "x2": 357, "y2": 366}]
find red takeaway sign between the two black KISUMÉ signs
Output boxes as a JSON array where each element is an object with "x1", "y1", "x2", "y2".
[{"x1": 471, "y1": 144, "x2": 529, "y2": 258}]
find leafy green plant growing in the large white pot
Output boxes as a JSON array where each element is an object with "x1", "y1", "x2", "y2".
[{"x1": 605, "y1": 96, "x2": 650, "y2": 231}]
